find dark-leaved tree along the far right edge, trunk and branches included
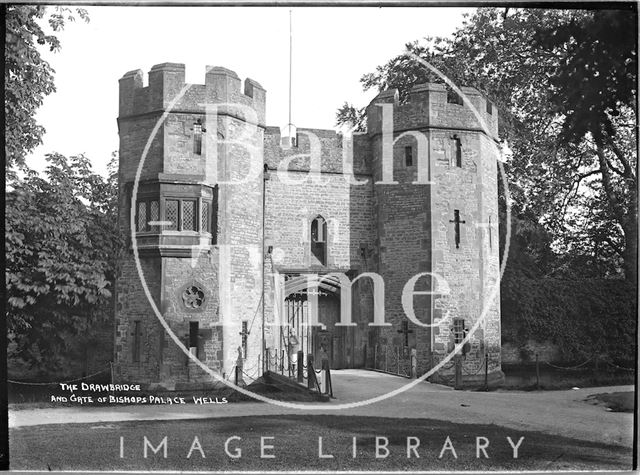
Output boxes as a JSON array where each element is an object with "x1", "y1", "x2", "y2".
[{"x1": 537, "y1": 9, "x2": 638, "y2": 282}]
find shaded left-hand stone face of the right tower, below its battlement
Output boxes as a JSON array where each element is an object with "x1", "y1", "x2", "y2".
[{"x1": 370, "y1": 124, "x2": 431, "y2": 374}]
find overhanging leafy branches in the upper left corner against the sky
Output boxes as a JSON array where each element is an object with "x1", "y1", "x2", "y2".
[{"x1": 4, "y1": 5, "x2": 89, "y2": 174}]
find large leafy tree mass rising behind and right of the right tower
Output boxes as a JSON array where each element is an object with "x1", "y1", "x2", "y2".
[{"x1": 338, "y1": 8, "x2": 637, "y2": 282}]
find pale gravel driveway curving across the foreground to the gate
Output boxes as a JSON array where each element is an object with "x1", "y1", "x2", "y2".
[{"x1": 9, "y1": 370, "x2": 634, "y2": 447}]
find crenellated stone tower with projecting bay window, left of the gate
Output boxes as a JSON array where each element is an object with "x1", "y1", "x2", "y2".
[{"x1": 115, "y1": 63, "x2": 266, "y2": 386}]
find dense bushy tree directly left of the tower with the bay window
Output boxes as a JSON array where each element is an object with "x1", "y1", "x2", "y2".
[{"x1": 5, "y1": 153, "x2": 121, "y2": 369}]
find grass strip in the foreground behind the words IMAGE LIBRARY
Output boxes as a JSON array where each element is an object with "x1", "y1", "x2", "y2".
[{"x1": 10, "y1": 415, "x2": 632, "y2": 471}]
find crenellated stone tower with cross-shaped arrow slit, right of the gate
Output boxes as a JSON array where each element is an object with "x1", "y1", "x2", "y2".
[{"x1": 367, "y1": 83, "x2": 503, "y2": 386}]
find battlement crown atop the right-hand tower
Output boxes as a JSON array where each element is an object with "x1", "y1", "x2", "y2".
[{"x1": 366, "y1": 83, "x2": 498, "y2": 139}]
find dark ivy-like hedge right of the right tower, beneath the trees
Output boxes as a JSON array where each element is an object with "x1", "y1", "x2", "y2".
[{"x1": 501, "y1": 268, "x2": 636, "y2": 362}]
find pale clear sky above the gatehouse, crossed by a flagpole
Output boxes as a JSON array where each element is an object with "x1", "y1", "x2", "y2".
[{"x1": 27, "y1": 6, "x2": 474, "y2": 174}]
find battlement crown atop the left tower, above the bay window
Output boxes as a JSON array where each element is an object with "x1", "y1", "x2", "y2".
[{"x1": 119, "y1": 63, "x2": 266, "y2": 126}]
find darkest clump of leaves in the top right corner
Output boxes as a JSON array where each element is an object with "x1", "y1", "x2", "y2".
[{"x1": 536, "y1": 9, "x2": 638, "y2": 141}]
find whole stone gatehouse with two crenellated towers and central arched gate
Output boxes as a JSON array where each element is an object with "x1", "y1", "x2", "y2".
[{"x1": 114, "y1": 63, "x2": 503, "y2": 387}]
